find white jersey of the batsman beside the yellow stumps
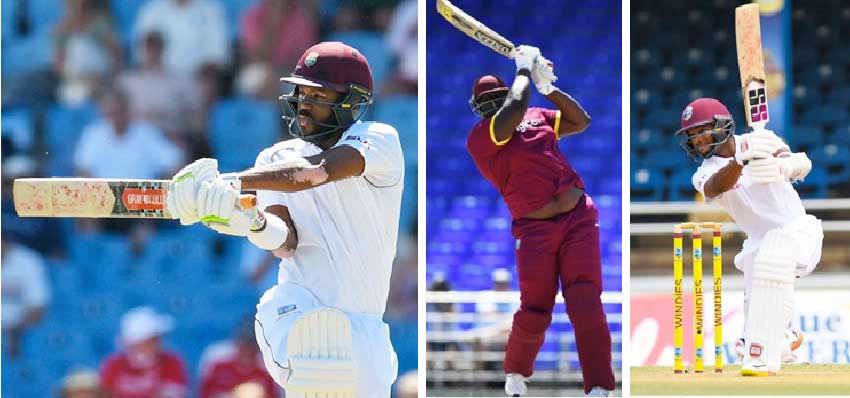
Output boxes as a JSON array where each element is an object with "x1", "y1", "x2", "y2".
[{"x1": 691, "y1": 156, "x2": 806, "y2": 240}]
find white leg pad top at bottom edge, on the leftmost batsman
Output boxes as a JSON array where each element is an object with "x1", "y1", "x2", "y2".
[{"x1": 286, "y1": 308, "x2": 356, "y2": 398}]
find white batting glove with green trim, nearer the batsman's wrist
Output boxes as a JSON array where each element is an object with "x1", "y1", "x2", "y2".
[{"x1": 197, "y1": 178, "x2": 265, "y2": 236}]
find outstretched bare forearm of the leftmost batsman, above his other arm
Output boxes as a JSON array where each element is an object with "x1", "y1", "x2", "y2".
[{"x1": 238, "y1": 164, "x2": 328, "y2": 192}]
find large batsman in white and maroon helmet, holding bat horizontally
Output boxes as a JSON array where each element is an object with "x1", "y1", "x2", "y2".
[{"x1": 168, "y1": 42, "x2": 404, "y2": 398}]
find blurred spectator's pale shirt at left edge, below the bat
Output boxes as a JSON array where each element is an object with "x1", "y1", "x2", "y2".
[{"x1": 0, "y1": 232, "x2": 50, "y2": 358}]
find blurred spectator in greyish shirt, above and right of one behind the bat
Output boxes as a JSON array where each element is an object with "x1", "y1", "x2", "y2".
[{"x1": 118, "y1": 30, "x2": 200, "y2": 141}]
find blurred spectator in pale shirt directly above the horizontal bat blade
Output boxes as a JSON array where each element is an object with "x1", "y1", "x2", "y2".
[{"x1": 74, "y1": 89, "x2": 183, "y2": 179}]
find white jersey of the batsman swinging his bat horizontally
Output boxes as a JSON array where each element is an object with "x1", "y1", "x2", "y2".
[{"x1": 256, "y1": 122, "x2": 404, "y2": 315}]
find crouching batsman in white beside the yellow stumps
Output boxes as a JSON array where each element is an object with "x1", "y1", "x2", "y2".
[{"x1": 676, "y1": 98, "x2": 823, "y2": 376}]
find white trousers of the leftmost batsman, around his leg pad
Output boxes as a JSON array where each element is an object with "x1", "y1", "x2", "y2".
[{"x1": 254, "y1": 283, "x2": 398, "y2": 398}]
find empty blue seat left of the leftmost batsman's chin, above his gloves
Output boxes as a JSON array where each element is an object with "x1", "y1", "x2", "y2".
[{"x1": 210, "y1": 98, "x2": 281, "y2": 171}]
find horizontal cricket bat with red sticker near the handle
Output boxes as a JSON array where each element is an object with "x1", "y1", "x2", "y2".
[{"x1": 12, "y1": 178, "x2": 257, "y2": 219}]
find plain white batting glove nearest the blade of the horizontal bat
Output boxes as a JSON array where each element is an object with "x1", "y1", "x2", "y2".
[{"x1": 166, "y1": 158, "x2": 218, "y2": 225}]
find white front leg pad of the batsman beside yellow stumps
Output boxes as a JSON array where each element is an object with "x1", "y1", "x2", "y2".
[{"x1": 742, "y1": 228, "x2": 796, "y2": 375}]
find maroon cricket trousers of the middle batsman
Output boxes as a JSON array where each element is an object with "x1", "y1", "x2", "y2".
[{"x1": 504, "y1": 195, "x2": 615, "y2": 393}]
